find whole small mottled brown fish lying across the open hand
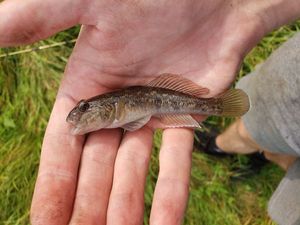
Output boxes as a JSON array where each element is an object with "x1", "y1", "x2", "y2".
[{"x1": 66, "y1": 74, "x2": 250, "y2": 135}]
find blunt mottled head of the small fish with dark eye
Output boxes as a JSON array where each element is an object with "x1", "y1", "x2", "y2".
[{"x1": 66, "y1": 100, "x2": 115, "y2": 135}]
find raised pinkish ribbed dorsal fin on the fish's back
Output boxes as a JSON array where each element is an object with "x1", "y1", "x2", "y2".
[{"x1": 147, "y1": 73, "x2": 209, "y2": 97}]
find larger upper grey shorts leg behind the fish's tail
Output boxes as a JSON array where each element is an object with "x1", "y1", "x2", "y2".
[{"x1": 237, "y1": 34, "x2": 300, "y2": 156}]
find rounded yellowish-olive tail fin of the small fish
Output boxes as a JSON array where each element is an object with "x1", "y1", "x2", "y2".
[{"x1": 220, "y1": 89, "x2": 250, "y2": 116}]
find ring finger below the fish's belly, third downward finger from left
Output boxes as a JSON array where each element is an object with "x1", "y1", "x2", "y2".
[{"x1": 107, "y1": 127, "x2": 153, "y2": 225}]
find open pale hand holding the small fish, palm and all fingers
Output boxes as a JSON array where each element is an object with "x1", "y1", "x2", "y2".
[{"x1": 0, "y1": 0, "x2": 300, "y2": 225}]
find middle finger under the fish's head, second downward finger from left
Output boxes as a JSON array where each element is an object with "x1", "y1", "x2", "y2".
[{"x1": 70, "y1": 130, "x2": 121, "y2": 224}]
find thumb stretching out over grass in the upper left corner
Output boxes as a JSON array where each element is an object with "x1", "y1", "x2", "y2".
[{"x1": 0, "y1": 0, "x2": 80, "y2": 47}]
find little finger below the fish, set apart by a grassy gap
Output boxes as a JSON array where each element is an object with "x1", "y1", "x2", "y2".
[{"x1": 150, "y1": 129, "x2": 193, "y2": 225}]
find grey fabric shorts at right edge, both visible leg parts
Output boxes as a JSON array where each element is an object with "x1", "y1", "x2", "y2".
[{"x1": 237, "y1": 34, "x2": 300, "y2": 225}]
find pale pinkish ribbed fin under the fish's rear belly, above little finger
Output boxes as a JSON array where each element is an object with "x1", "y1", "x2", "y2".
[{"x1": 156, "y1": 114, "x2": 200, "y2": 128}]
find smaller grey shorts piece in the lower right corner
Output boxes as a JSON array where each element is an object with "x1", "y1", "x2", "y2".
[{"x1": 268, "y1": 159, "x2": 300, "y2": 225}]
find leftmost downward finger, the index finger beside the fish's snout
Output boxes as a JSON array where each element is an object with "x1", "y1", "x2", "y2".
[{"x1": 31, "y1": 97, "x2": 84, "y2": 225}]
